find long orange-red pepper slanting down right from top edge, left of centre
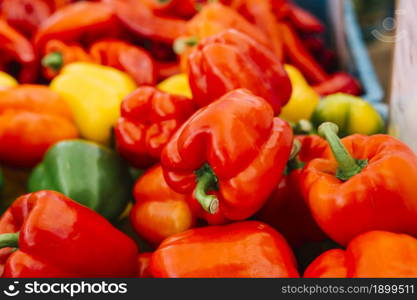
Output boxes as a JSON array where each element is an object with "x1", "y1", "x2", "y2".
[{"x1": 104, "y1": 0, "x2": 186, "y2": 44}]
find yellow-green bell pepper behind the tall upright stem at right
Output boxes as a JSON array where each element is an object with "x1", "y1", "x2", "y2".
[{"x1": 311, "y1": 93, "x2": 385, "y2": 137}]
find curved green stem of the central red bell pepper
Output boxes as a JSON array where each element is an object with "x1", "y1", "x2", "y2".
[{"x1": 194, "y1": 164, "x2": 219, "y2": 214}]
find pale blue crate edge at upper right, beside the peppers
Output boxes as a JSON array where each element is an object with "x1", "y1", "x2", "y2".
[{"x1": 296, "y1": 0, "x2": 388, "y2": 120}]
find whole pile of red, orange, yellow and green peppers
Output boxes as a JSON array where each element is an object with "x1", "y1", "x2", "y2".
[{"x1": 0, "y1": 0, "x2": 417, "y2": 278}]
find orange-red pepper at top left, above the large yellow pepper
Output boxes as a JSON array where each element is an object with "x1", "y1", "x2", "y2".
[{"x1": 33, "y1": 1, "x2": 121, "y2": 53}]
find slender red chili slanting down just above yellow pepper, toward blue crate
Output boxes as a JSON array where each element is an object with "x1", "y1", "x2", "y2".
[{"x1": 278, "y1": 22, "x2": 329, "y2": 84}]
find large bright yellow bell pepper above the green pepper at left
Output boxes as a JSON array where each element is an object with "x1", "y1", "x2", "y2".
[{"x1": 51, "y1": 62, "x2": 136, "y2": 144}]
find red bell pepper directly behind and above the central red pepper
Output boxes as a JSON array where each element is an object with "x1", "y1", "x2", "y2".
[{"x1": 188, "y1": 29, "x2": 292, "y2": 114}]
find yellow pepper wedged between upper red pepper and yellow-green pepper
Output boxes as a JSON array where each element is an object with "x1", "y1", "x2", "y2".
[{"x1": 280, "y1": 65, "x2": 320, "y2": 123}]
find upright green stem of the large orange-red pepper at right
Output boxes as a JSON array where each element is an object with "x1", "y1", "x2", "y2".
[{"x1": 318, "y1": 122, "x2": 368, "y2": 181}]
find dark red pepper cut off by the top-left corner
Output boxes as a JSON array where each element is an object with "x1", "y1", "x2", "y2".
[{"x1": 1, "y1": 0, "x2": 71, "y2": 37}]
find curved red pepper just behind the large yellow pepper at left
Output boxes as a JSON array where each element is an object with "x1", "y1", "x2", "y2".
[{"x1": 89, "y1": 39, "x2": 157, "y2": 86}]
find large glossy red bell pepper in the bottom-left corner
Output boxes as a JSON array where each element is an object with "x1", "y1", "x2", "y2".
[{"x1": 0, "y1": 191, "x2": 138, "y2": 278}]
